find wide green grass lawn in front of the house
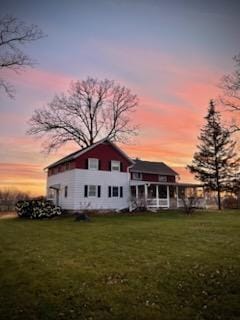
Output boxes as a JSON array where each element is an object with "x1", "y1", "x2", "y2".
[{"x1": 0, "y1": 211, "x2": 240, "y2": 320}]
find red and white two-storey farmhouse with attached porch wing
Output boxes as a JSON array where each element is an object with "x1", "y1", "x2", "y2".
[{"x1": 46, "y1": 139, "x2": 205, "y2": 210}]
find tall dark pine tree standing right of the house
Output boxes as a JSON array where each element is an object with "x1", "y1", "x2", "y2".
[{"x1": 187, "y1": 100, "x2": 239, "y2": 210}]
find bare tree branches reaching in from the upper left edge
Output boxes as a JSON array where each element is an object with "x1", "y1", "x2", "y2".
[{"x1": 0, "y1": 15, "x2": 44, "y2": 98}]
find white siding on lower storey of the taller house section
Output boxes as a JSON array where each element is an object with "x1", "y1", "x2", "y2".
[{"x1": 47, "y1": 169, "x2": 130, "y2": 210}]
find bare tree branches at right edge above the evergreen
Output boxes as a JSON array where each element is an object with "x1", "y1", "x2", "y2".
[{"x1": 220, "y1": 53, "x2": 240, "y2": 131}]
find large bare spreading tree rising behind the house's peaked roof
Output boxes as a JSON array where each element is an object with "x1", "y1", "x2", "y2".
[{"x1": 28, "y1": 78, "x2": 138, "y2": 152}]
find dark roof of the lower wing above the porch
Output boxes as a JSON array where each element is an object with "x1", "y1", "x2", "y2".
[{"x1": 131, "y1": 159, "x2": 178, "y2": 176}]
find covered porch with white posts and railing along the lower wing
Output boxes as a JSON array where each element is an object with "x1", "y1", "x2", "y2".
[{"x1": 130, "y1": 181, "x2": 206, "y2": 209}]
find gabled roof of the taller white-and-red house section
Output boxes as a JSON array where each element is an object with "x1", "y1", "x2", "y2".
[{"x1": 45, "y1": 138, "x2": 134, "y2": 169}]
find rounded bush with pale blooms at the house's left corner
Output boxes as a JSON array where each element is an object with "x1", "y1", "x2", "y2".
[{"x1": 16, "y1": 199, "x2": 62, "y2": 219}]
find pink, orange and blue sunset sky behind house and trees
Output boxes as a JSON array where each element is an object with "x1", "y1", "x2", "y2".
[{"x1": 0, "y1": 0, "x2": 240, "y2": 195}]
